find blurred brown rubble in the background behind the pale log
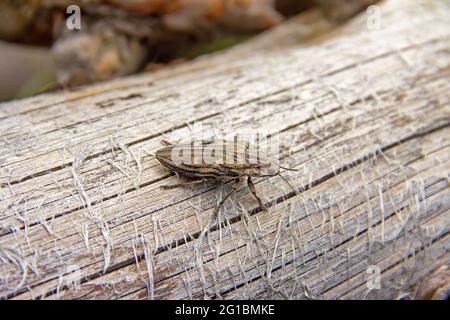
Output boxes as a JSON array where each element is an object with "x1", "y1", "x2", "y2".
[{"x1": 0, "y1": 0, "x2": 377, "y2": 100}]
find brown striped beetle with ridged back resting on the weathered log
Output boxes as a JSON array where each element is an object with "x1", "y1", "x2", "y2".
[{"x1": 155, "y1": 138, "x2": 297, "y2": 219}]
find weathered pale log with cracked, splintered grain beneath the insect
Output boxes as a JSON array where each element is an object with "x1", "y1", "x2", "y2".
[{"x1": 0, "y1": 0, "x2": 450, "y2": 299}]
